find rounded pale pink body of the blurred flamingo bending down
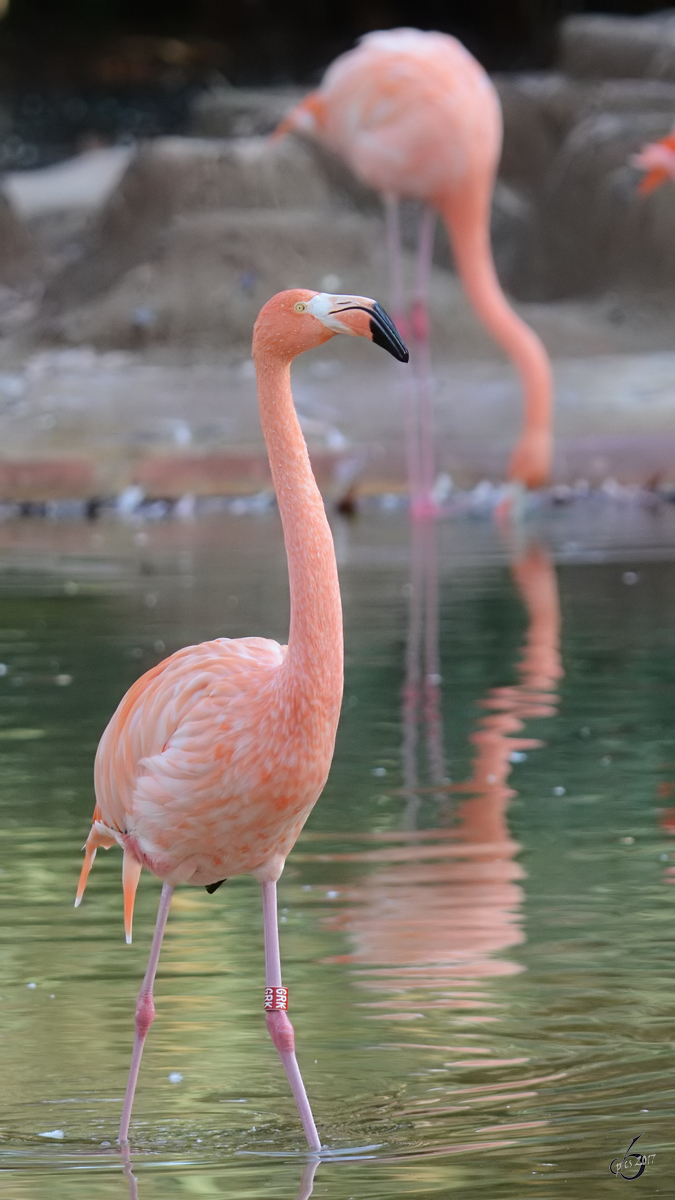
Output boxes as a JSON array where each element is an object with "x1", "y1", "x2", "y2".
[{"x1": 296, "y1": 29, "x2": 502, "y2": 203}]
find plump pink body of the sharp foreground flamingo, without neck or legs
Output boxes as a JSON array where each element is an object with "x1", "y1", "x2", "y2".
[{"x1": 94, "y1": 637, "x2": 342, "y2": 886}]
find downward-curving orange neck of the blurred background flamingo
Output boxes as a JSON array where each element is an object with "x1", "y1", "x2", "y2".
[{"x1": 438, "y1": 194, "x2": 552, "y2": 431}]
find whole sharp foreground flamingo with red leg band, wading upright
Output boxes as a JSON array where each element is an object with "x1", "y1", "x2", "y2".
[{"x1": 76, "y1": 288, "x2": 408, "y2": 1150}]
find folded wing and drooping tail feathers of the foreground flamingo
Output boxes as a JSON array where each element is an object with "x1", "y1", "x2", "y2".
[{"x1": 77, "y1": 637, "x2": 293, "y2": 907}]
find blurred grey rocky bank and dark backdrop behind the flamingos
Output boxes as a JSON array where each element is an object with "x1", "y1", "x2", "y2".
[{"x1": 0, "y1": 0, "x2": 675, "y2": 504}]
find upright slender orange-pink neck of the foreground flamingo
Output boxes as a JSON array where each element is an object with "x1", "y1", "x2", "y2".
[{"x1": 256, "y1": 354, "x2": 344, "y2": 709}]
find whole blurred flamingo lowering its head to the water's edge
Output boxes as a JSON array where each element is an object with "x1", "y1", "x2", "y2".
[{"x1": 277, "y1": 29, "x2": 552, "y2": 515}]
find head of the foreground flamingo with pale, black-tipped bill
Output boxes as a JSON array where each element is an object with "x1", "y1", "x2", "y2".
[{"x1": 253, "y1": 288, "x2": 408, "y2": 362}]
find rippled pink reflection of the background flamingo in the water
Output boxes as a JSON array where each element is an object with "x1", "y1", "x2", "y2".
[{"x1": 330, "y1": 540, "x2": 562, "y2": 1027}]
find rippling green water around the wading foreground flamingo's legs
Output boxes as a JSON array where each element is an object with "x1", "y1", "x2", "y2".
[{"x1": 0, "y1": 503, "x2": 675, "y2": 1200}]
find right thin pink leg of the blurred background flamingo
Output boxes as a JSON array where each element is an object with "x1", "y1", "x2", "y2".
[{"x1": 411, "y1": 206, "x2": 438, "y2": 518}]
